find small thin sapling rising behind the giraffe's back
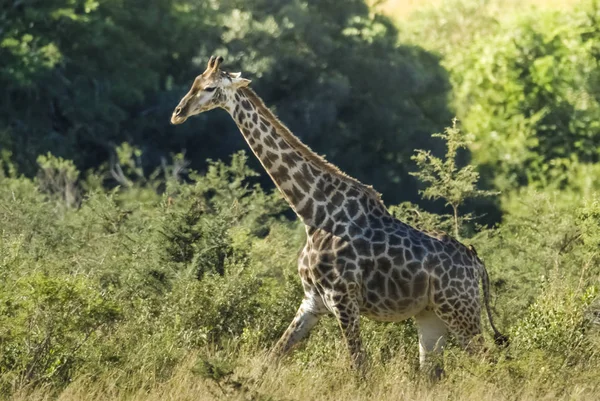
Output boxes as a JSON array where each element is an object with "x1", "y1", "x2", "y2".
[{"x1": 410, "y1": 118, "x2": 497, "y2": 238}]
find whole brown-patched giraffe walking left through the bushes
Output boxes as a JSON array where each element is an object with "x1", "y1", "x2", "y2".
[{"x1": 171, "y1": 56, "x2": 506, "y2": 371}]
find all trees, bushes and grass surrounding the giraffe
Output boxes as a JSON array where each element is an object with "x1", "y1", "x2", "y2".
[{"x1": 0, "y1": 0, "x2": 600, "y2": 400}]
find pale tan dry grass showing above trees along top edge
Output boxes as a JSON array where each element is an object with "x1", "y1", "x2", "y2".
[{"x1": 371, "y1": 0, "x2": 580, "y2": 20}]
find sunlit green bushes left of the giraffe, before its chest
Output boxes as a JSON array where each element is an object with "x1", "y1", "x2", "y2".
[{"x1": 0, "y1": 150, "x2": 301, "y2": 389}]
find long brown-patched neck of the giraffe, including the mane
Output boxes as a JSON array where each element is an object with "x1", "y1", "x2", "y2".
[{"x1": 225, "y1": 88, "x2": 387, "y2": 232}]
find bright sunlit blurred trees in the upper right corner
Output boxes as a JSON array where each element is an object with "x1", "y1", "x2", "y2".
[{"x1": 412, "y1": 1, "x2": 600, "y2": 189}]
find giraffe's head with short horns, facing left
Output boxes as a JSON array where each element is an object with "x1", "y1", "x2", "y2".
[{"x1": 171, "y1": 56, "x2": 250, "y2": 124}]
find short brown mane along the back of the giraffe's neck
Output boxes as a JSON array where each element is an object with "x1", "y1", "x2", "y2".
[{"x1": 239, "y1": 87, "x2": 383, "y2": 205}]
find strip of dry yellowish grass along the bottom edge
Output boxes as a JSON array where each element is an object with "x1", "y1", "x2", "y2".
[{"x1": 9, "y1": 352, "x2": 599, "y2": 401}]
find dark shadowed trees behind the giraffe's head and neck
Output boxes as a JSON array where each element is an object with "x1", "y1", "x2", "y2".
[{"x1": 0, "y1": 0, "x2": 450, "y2": 206}]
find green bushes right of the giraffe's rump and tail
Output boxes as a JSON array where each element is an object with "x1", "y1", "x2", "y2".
[{"x1": 470, "y1": 188, "x2": 600, "y2": 334}]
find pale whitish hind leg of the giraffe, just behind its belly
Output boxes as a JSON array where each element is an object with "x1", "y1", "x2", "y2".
[{"x1": 415, "y1": 309, "x2": 448, "y2": 379}]
